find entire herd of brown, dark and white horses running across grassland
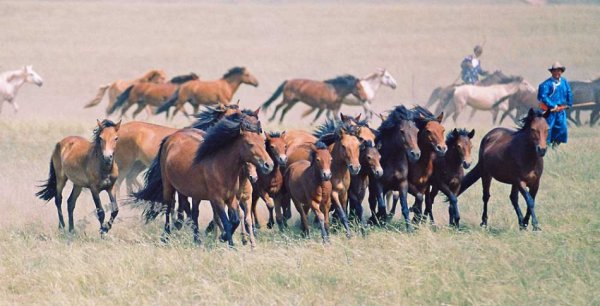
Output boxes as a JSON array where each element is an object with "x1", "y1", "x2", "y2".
[{"x1": 0, "y1": 66, "x2": 600, "y2": 246}]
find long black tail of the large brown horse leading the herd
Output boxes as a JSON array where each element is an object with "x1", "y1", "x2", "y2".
[{"x1": 133, "y1": 137, "x2": 168, "y2": 222}]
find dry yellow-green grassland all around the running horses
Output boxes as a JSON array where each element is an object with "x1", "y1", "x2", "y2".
[{"x1": 0, "y1": 1, "x2": 600, "y2": 305}]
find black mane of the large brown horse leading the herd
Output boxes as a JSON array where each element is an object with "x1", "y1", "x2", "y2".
[{"x1": 194, "y1": 113, "x2": 262, "y2": 164}]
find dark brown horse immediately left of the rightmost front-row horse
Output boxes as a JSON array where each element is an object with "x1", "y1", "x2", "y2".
[{"x1": 425, "y1": 129, "x2": 475, "y2": 227}]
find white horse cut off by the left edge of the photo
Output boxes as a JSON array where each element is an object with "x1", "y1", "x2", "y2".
[{"x1": 0, "y1": 65, "x2": 44, "y2": 113}]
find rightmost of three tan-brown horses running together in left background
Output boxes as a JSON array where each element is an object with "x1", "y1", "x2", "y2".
[{"x1": 156, "y1": 67, "x2": 258, "y2": 118}]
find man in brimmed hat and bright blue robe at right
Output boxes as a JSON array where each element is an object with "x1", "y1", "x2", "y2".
[{"x1": 538, "y1": 62, "x2": 573, "y2": 145}]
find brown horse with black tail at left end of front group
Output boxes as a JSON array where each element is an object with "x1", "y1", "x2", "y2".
[{"x1": 36, "y1": 120, "x2": 121, "y2": 235}]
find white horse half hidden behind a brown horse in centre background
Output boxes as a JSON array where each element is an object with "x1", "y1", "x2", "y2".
[{"x1": 342, "y1": 68, "x2": 398, "y2": 119}]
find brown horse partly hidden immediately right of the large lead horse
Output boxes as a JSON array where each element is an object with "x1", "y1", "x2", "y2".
[{"x1": 252, "y1": 132, "x2": 287, "y2": 228}]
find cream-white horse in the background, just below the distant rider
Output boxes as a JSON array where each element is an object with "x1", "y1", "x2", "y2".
[{"x1": 444, "y1": 79, "x2": 534, "y2": 124}]
